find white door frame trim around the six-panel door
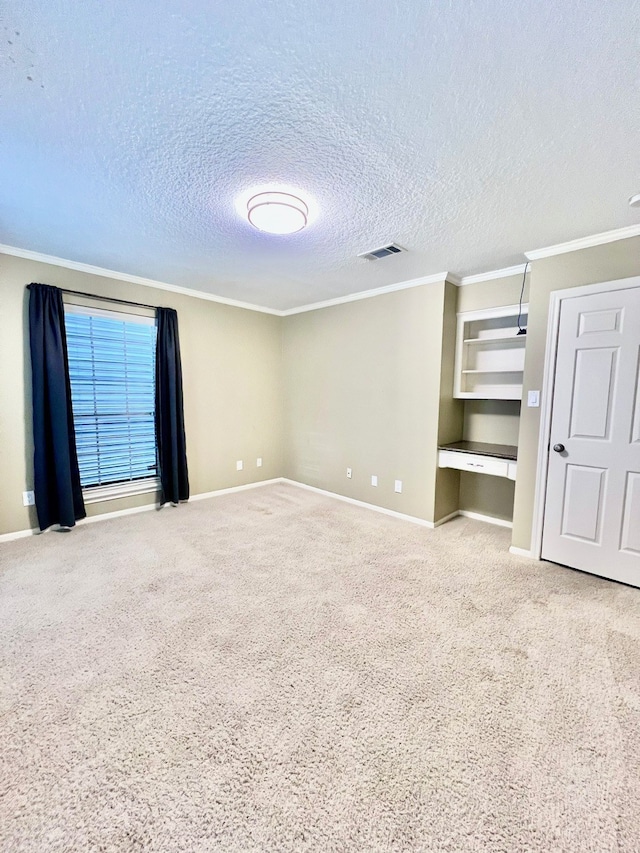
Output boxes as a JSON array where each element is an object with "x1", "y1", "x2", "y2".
[{"x1": 531, "y1": 276, "x2": 640, "y2": 560}]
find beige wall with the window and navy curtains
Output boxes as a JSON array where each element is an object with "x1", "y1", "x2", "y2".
[{"x1": 0, "y1": 250, "x2": 283, "y2": 533}]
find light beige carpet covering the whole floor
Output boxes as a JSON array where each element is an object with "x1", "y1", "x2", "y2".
[{"x1": 0, "y1": 485, "x2": 640, "y2": 853}]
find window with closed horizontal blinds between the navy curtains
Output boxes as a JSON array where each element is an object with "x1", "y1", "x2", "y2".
[{"x1": 65, "y1": 305, "x2": 158, "y2": 502}]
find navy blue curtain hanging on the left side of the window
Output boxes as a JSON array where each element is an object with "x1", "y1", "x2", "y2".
[{"x1": 28, "y1": 284, "x2": 86, "y2": 530}]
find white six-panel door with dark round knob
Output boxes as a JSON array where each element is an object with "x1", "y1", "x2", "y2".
[{"x1": 542, "y1": 286, "x2": 640, "y2": 586}]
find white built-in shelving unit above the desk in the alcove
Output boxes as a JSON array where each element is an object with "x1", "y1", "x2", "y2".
[{"x1": 454, "y1": 305, "x2": 529, "y2": 400}]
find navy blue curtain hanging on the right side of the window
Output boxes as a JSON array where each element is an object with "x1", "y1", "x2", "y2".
[{"x1": 156, "y1": 308, "x2": 189, "y2": 504}]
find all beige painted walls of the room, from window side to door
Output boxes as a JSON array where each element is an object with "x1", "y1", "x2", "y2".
[{"x1": 0, "y1": 237, "x2": 640, "y2": 549}]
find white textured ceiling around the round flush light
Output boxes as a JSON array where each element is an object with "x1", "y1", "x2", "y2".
[{"x1": 0, "y1": 0, "x2": 640, "y2": 309}]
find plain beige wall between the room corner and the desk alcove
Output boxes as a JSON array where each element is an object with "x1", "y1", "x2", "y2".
[{"x1": 284, "y1": 282, "x2": 451, "y2": 521}]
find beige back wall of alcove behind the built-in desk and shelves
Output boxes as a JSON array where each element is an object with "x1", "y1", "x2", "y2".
[{"x1": 458, "y1": 274, "x2": 530, "y2": 521}]
